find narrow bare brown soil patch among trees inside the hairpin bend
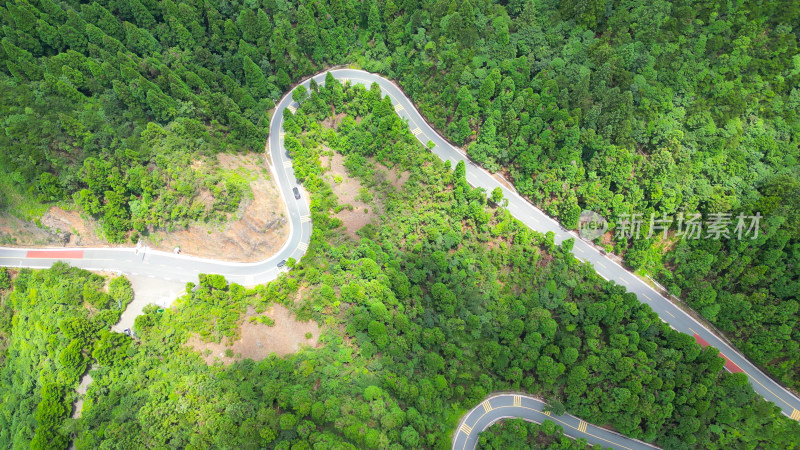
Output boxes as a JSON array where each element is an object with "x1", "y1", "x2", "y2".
[{"x1": 320, "y1": 149, "x2": 380, "y2": 238}]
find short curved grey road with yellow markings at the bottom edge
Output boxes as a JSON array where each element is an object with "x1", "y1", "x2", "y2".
[{"x1": 453, "y1": 394, "x2": 658, "y2": 450}]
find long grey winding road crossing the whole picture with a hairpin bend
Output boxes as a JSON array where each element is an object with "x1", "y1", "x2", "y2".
[{"x1": 0, "y1": 69, "x2": 800, "y2": 426}]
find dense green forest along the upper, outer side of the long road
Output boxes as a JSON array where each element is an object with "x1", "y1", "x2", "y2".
[{"x1": 0, "y1": 0, "x2": 800, "y2": 386}]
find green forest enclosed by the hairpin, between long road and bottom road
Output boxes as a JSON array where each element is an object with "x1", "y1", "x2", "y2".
[{"x1": 64, "y1": 82, "x2": 800, "y2": 448}]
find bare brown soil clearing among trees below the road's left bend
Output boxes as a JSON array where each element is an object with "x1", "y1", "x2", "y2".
[{"x1": 186, "y1": 305, "x2": 320, "y2": 365}]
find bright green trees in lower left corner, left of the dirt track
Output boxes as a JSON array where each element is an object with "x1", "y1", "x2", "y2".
[{"x1": 0, "y1": 263, "x2": 133, "y2": 448}]
